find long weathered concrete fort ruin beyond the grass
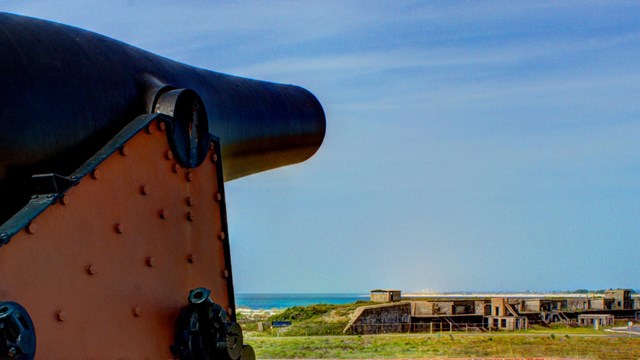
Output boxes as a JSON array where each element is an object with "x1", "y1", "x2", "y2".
[{"x1": 345, "y1": 289, "x2": 640, "y2": 334}]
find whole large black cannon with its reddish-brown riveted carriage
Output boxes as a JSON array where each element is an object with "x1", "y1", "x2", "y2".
[{"x1": 0, "y1": 13, "x2": 325, "y2": 360}]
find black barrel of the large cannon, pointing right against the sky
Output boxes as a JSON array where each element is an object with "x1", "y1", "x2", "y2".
[{"x1": 0, "y1": 13, "x2": 325, "y2": 180}]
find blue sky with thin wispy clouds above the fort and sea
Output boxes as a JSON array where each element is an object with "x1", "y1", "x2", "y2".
[{"x1": 5, "y1": 0, "x2": 640, "y2": 292}]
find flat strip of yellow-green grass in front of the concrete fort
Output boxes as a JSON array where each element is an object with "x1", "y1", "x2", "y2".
[{"x1": 245, "y1": 332, "x2": 640, "y2": 359}]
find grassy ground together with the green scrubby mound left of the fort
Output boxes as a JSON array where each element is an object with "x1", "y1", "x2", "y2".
[{"x1": 243, "y1": 303, "x2": 640, "y2": 359}]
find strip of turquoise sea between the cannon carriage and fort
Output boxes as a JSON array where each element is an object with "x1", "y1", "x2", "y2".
[{"x1": 236, "y1": 294, "x2": 369, "y2": 310}]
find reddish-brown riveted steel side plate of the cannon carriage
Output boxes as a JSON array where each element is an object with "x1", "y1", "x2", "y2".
[{"x1": 0, "y1": 121, "x2": 235, "y2": 359}]
